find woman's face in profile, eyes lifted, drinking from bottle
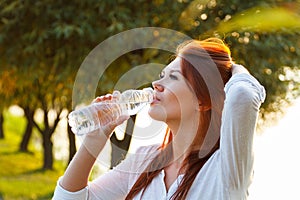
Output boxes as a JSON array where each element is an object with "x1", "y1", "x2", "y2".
[{"x1": 149, "y1": 57, "x2": 198, "y2": 124}]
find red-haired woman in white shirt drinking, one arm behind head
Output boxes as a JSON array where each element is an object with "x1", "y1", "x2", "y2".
[{"x1": 53, "y1": 38, "x2": 265, "y2": 200}]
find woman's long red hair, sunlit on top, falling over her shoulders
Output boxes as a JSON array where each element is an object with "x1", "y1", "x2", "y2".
[{"x1": 126, "y1": 38, "x2": 231, "y2": 200}]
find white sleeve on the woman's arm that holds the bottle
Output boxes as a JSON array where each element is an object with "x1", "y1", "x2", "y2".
[{"x1": 53, "y1": 146, "x2": 157, "y2": 200}]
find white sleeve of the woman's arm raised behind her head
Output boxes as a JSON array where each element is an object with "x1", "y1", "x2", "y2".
[{"x1": 220, "y1": 73, "x2": 265, "y2": 194}]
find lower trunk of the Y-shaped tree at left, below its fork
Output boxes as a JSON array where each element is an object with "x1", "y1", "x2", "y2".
[{"x1": 42, "y1": 129, "x2": 53, "y2": 170}]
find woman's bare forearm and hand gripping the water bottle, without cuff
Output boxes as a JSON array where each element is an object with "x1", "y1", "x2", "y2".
[{"x1": 60, "y1": 92, "x2": 129, "y2": 192}]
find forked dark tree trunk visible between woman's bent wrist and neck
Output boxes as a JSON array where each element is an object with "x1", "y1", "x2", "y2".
[{"x1": 110, "y1": 115, "x2": 136, "y2": 169}]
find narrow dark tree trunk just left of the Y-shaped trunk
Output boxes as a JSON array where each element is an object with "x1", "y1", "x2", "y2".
[{"x1": 19, "y1": 107, "x2": 34, "y2": 152}]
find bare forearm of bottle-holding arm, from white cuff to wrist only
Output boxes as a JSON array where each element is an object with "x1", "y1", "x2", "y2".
[{"x1": 60, "y1": 133, "x2": 107, "y2": 192}]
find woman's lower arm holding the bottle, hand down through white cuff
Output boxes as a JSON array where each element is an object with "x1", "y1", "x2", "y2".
[{"x1": 53, "y1": 95, "x2": 128, "y2": 200}]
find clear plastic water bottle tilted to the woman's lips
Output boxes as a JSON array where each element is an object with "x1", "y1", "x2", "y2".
[{"x1": 68, "y1": 88, "x2": 153, "y2": 135}]
